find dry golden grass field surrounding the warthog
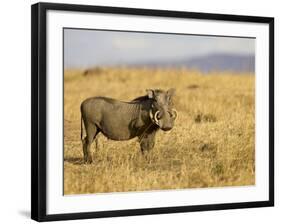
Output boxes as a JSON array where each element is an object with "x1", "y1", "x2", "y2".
[{"x1": 64, "y1": 68, "x2": 255, "y2": 194}]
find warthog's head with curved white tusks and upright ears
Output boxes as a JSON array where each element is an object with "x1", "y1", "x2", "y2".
[{"x1": 146, "y1": 89, "x2": 177, "y2": 131}]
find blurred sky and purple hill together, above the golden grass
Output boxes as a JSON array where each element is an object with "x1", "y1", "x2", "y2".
[{"x1": 64, "y1": 29, "x2": 255, "y2": 73}]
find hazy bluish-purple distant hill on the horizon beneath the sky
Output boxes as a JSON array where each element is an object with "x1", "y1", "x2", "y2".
[{"x1": 131, "y1": 53, "x2": 255, "y2": 73}]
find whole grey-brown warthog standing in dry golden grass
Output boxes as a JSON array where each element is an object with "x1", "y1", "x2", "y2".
[{"x1": 80, "y1": 88, "x2": 177, "y2": 163}]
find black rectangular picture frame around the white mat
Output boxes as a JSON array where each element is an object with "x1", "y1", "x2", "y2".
[{"x1": 31, "y1": 3, "x2": 274, "y2": 221}]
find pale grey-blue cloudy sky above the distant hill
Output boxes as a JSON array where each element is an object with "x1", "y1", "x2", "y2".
[{"x1": 64, "y1": 29, "x2": 255, "y2": 68}]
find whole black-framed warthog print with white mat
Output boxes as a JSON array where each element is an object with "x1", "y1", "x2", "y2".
[{"x1": 31, "y1": 3, "x2": 274, "y2": 221}]
